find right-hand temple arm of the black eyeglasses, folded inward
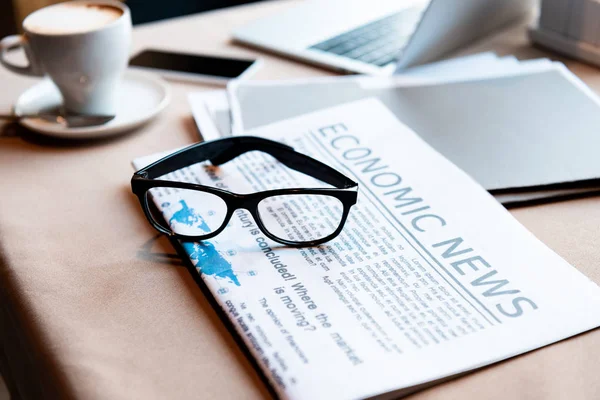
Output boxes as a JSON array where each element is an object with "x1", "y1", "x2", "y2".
[{"x1": 210, "y1": 136, "x2": 356, "y2": 189}]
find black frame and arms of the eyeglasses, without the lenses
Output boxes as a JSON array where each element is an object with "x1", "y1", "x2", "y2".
[{"x1": 131, "y1": 136, "x2": 358, "y2": 247}]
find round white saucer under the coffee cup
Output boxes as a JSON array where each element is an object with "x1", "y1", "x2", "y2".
[{"x1": 14, "y1": 70, "x2": 171, "y2": 139}]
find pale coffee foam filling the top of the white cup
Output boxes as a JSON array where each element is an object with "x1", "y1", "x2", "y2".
[{"x1": 23, "y1": 3, "x2": 123, "y2": 35}]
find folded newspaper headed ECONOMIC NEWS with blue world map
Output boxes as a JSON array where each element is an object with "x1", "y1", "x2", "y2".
[{"x1": 134, "y1": 99, "x2": 600, "y2": 400}]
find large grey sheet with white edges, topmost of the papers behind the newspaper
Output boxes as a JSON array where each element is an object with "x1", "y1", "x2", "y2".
[{"x1": 230, "y1": 62, "x2": 600, "y2": 191}]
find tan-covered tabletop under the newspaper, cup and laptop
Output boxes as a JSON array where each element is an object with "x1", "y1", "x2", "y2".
[{"x1": 0, "y1": 1, "x2": 600, "y2": 400}]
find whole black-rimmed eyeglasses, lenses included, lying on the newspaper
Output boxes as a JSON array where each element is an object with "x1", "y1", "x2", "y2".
[{"x1": 131, "y1": 136, "x2": 358, "y2": 247}]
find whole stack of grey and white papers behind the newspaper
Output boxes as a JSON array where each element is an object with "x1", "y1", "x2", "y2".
[{"x1": 190, "y1": 53, "x2": 600, "y2": 206}]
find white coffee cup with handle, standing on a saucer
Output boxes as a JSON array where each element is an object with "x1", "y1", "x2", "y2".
[{"x1": 0, "y1": 0, "x2": 131, "y2": 115}]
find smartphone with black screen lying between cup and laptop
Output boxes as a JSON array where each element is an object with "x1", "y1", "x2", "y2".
[{"x1": 129, "y1": 49, "x2": 260, "y2": 85}]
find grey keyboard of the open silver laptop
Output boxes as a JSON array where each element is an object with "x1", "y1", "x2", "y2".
[{"x1": 310, "y1": 7, "x2": 424, "y2": 67}]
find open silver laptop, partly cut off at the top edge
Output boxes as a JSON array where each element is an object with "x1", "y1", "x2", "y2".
[{"x1": 233, "y1": 0, "x2": 533, "y2": 75}]
